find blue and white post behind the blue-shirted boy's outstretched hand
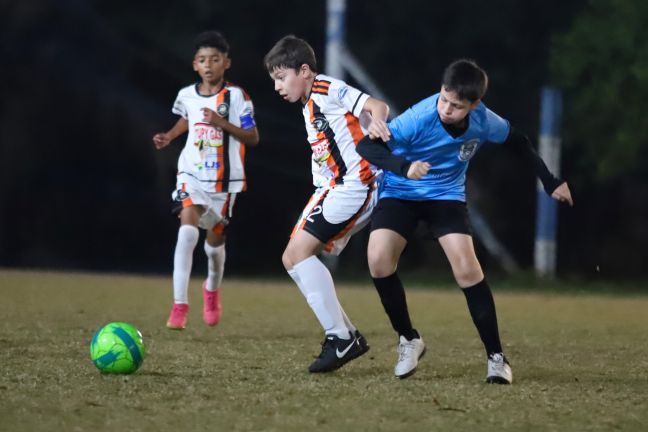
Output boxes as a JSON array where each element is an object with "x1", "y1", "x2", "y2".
[{"x1": 534, "y1": 87, "x2": 562, "y2": 277}]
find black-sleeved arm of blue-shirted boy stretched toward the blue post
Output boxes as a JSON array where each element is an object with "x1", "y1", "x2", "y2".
[{"x1": 504, "y1": 128, "x2": 574, "y2": 206}]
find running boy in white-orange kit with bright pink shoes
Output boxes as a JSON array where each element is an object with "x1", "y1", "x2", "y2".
[{"x1": 153, "y1": 31, "x2": 259, "y2": 330}]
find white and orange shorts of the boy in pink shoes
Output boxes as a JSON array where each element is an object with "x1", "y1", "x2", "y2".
[{"x1": 171, "y1": 178, "x2": 236, "y2": 234}]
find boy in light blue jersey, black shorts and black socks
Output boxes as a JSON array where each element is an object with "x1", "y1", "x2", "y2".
[{"x1": 357, "y1": 60, "x2": 573, "y2": 384}]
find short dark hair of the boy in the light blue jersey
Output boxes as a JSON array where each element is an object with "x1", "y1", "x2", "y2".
[{"x1": 441, "y1": 59, "x2": 488, "y2": 102}]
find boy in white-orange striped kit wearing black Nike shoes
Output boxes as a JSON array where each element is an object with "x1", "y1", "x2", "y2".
[{"x1": 264, "y1": 36, "x2": 389, "y2": 372}]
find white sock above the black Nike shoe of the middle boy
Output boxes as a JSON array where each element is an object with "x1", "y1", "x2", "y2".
[{"x1": 288, "y1": 256, "x2": 349, "y2": 339}]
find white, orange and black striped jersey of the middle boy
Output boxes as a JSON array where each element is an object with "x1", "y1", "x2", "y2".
[{"x1": 302, "y1": 74, "x2": 377, "y2": 188}]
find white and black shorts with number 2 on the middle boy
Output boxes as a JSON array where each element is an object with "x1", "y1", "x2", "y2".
[{"x1": 290, "y1": 183, "x2": 378, "y2": 255}]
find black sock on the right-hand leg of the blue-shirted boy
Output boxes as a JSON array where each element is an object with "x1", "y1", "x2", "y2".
[{"x1": 462, "y1": 279, "x2": 502, "y2": 355}]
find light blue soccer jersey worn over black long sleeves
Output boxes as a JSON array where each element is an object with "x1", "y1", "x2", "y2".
[{"x1": 380, "y1": 93, "x2": 510, "y2": 201}]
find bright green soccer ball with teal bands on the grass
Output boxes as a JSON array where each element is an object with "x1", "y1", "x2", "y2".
[{"x1": 90, "y1": 322, "x2": 146, "y2": 374}]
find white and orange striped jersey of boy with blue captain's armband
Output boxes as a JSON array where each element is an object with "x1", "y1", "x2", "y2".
[{"x1": 171, "y1": 82, "x2": 256, "y2": 192}]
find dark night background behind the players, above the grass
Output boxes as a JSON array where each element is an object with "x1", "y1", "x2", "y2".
[{"x1": 0, "y1": 0, "x2": 648, "y2": 280}]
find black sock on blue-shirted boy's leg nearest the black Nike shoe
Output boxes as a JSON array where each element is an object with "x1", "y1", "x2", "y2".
[{"x1": 373, "y1": 273, "x2": 420, "y2": 340}]
